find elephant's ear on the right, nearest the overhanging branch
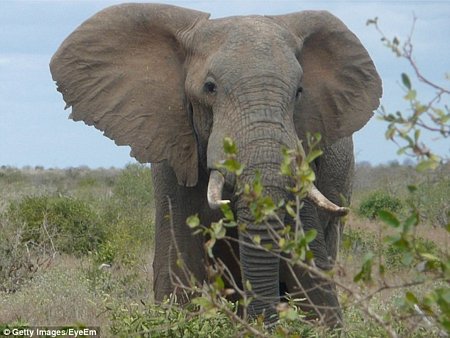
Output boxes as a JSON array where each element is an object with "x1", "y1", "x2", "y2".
[{"x1": 273, "y1": 11, "x2": 382, "y2": 143}]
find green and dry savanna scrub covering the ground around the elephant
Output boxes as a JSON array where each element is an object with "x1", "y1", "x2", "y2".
[{"x1": 0, "y1": 163, "x2": 450, "y2": 337}]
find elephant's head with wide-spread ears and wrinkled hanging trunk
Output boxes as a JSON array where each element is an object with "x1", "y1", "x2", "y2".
[{"x1": 50, "y1": 4, "x2": 381, "y2": 324}]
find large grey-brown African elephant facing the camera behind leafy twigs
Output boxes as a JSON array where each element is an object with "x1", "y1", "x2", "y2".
[{"x1": 50, "y1": 3, "x2": 382, "y2": 326}]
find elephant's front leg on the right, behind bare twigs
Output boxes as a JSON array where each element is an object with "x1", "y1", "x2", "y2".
[{"x1": 281, "y1": 201, "x2": 342, "y2": 327}]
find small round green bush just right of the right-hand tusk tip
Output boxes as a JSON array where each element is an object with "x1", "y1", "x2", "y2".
[{"x1": 358, "y1": 191, "x2": 402, "y2": 219}]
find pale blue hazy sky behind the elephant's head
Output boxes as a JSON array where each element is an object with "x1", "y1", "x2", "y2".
[{"x1": 0, "y1": 0, "x2": 450, "y2": 168}]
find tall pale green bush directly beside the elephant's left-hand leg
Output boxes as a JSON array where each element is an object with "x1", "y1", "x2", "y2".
[{"x1": 82, "y1": 164, "x2": 154, "y2": 297}]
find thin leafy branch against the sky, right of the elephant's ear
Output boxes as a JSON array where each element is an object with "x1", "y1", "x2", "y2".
[{"x1": 367, "y1": 17, "x2": 450, "y2": 171}]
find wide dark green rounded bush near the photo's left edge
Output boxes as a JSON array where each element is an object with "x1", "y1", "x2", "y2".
[{"x1": 6, "y1": 196, "x2": 106, "y2": 256}]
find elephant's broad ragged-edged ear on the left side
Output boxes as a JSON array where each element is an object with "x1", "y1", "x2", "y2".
[{"x1": 50, "y1": 4, "x2": 209, "y2": 186}]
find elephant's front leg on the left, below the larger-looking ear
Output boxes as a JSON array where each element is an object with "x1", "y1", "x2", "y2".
[{"x1": 152, "y1": 162, "x2": 206, "y2": 301}]
